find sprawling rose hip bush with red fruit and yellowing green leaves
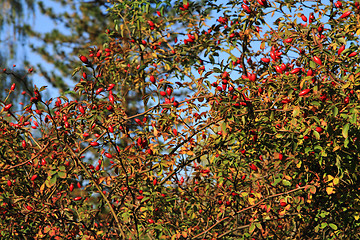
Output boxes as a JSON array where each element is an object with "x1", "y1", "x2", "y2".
[{"x1": 0, "y1": 0, "x2": 360, "y2": 239}]
